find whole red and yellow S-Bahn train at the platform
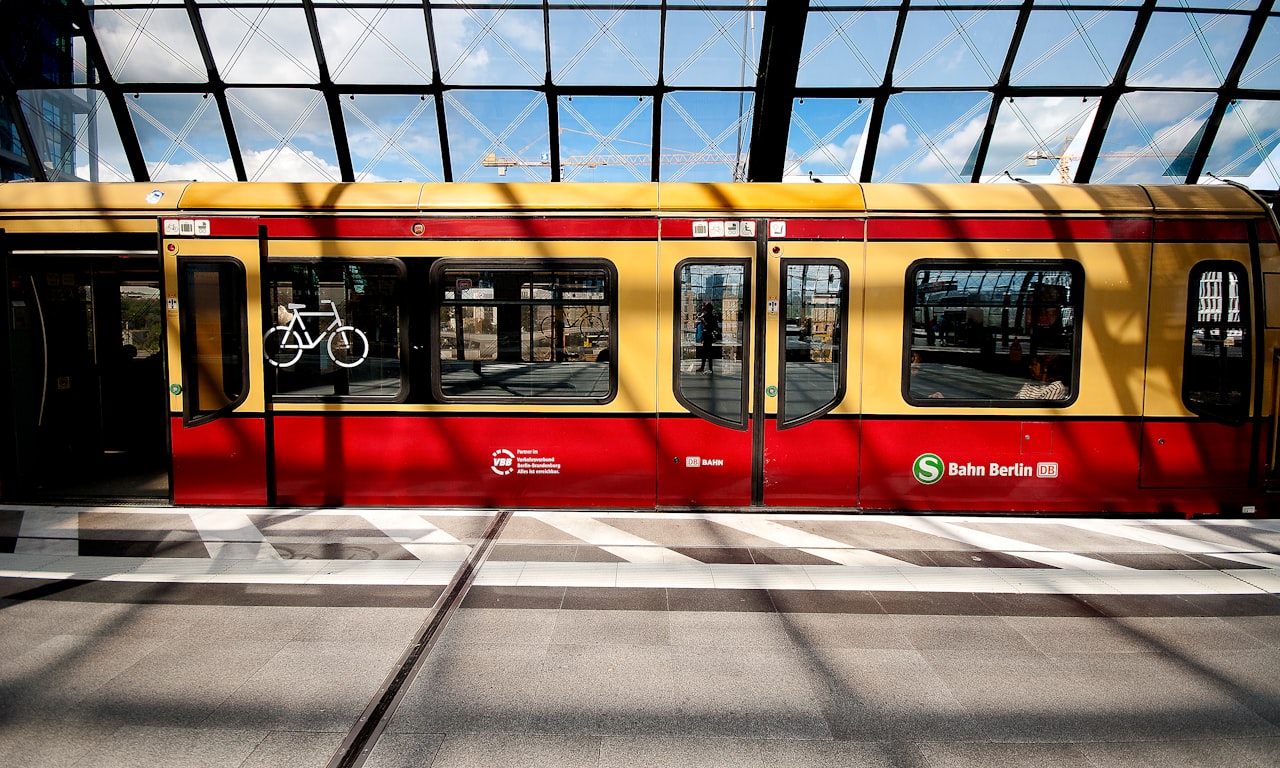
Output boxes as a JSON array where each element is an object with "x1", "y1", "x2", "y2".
[{"x1": 0, "y1": 182, "x2": 1280, "y2": 515}]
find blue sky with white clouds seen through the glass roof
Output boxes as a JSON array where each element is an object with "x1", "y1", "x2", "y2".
[{"x1": 19, "y1": 0, "x2": 1280, "y2": 188}]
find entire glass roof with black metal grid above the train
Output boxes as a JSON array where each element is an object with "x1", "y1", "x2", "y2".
[{"x1": 0, "y1": 0, "x2": 1280, "y2": 191}]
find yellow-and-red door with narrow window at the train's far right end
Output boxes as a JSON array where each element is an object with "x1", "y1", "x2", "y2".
[{"x1": 1140, "y1": 188, "x2": 1265, "y2": 513}]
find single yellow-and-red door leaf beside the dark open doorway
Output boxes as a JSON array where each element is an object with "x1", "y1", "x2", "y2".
[{"x1": 163, "y1": 219, "x2": 271, "y2": 506}]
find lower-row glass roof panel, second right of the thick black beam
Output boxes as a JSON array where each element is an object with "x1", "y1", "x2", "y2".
[{"x1": 872, "y1": 91, "x2": 991, "y2": 182}]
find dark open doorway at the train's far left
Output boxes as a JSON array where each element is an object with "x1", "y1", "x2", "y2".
[{"x1": 3, "y1": 250, "x2": 169, "y2": 502}]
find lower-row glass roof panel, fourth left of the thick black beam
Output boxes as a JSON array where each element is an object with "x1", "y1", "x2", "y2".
[{"x1": 342, "y1": 93, "x2": 444, "y2": 182}]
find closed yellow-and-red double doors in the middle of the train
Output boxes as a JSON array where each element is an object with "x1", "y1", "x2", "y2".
[{"x1": 658, "y1": 220, "x2": 861, "y2": 507}]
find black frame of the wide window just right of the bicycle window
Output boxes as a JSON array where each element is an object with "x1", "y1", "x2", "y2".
[{"x1": 426, "y1": 256, "x2": 620, "y2": 407}]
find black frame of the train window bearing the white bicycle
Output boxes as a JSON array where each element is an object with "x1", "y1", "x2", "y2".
[{"x1": 262, "y1": 256, "x2": 410, "y2": 403}]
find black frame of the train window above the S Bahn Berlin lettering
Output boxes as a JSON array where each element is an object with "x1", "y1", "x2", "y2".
[{"x1": 901, "y1": 257, "x2": 1087, "y2": 410}]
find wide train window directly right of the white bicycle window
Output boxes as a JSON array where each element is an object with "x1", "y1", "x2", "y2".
[{"x1": 431, "y1": 259, "x2": 617, "y2": 403}]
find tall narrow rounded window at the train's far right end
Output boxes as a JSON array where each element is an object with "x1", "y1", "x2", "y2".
[{"x1": 1183, "y1": 261, "x2": 1252, "y2": 422}]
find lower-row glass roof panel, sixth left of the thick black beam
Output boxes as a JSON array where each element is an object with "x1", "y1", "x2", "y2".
[{"x1": 127, "y1": 93, "x2": 236, "y2": 182}]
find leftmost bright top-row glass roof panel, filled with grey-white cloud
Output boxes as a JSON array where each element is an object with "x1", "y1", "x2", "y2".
[{"x1": 92, "y1": 8, "x2": 209, "y2": 83}]
